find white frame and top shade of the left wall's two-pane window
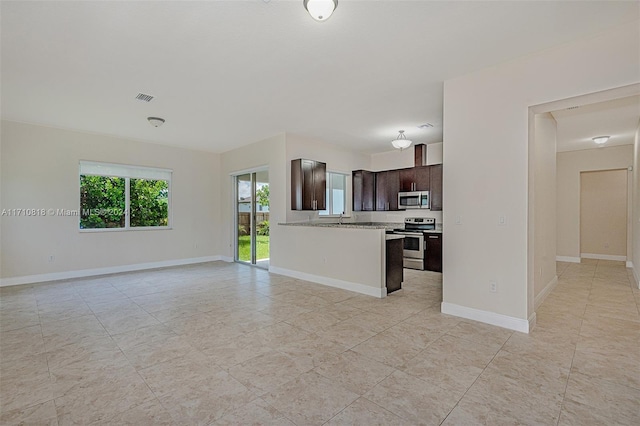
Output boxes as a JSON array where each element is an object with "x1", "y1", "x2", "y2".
[{"x1": 78, "y1": 161, "x2": 173, "y2": 233}]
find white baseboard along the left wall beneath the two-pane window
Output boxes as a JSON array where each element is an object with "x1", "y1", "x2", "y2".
[{"x1": 0, "y1": 256, "x2": 222, "y2": 287}]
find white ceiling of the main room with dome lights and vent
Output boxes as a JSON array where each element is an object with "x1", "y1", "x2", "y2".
[{"x1": 0, "y1": 0, "x2": 640, "y2": 153}]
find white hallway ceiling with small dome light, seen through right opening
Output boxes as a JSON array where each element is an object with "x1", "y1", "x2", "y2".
[{"x1": 551, "y1": 96, "x2": 640, "y2": 152}]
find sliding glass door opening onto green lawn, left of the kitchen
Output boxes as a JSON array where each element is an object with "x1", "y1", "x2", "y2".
[{"x1": 235, "y1": 170, "x2": 270, "y2": 269}]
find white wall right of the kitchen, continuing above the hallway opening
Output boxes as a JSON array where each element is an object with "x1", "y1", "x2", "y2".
[{"x1": 443, "y1": 20, "x2": 640, "y2": 329}]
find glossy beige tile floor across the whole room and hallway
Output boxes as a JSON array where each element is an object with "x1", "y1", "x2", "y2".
[{"x1": 0, "y1": 261, "x2": 640, "y2": 426}]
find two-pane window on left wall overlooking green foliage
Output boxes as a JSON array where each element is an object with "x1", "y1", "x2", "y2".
[{"x1": 79, "y1": 161, "x2": 172, "y2": 229}]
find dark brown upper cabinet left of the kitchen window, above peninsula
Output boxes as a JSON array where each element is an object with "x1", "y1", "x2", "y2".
[{"x1": 291, "y1": 159, "x2": 327, "y2": 210}]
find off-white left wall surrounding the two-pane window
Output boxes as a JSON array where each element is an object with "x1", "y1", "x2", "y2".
[{"x1": 0, "y1": 121, "x2": 220, "y2": 282}]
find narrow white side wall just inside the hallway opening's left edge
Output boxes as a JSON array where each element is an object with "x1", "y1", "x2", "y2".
[{"x1": 530, "y1": 113, "x2": 557, "y2": 305}]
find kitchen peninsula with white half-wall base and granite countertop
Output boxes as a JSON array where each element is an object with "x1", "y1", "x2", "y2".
[{"x1": 270, "y1": 222, "x2": 402, "y2": 298}]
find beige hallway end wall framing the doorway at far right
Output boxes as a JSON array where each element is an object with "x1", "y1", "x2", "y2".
[{"x1": 556, "y1": 145, "x2": 633, "y2": 259}]
